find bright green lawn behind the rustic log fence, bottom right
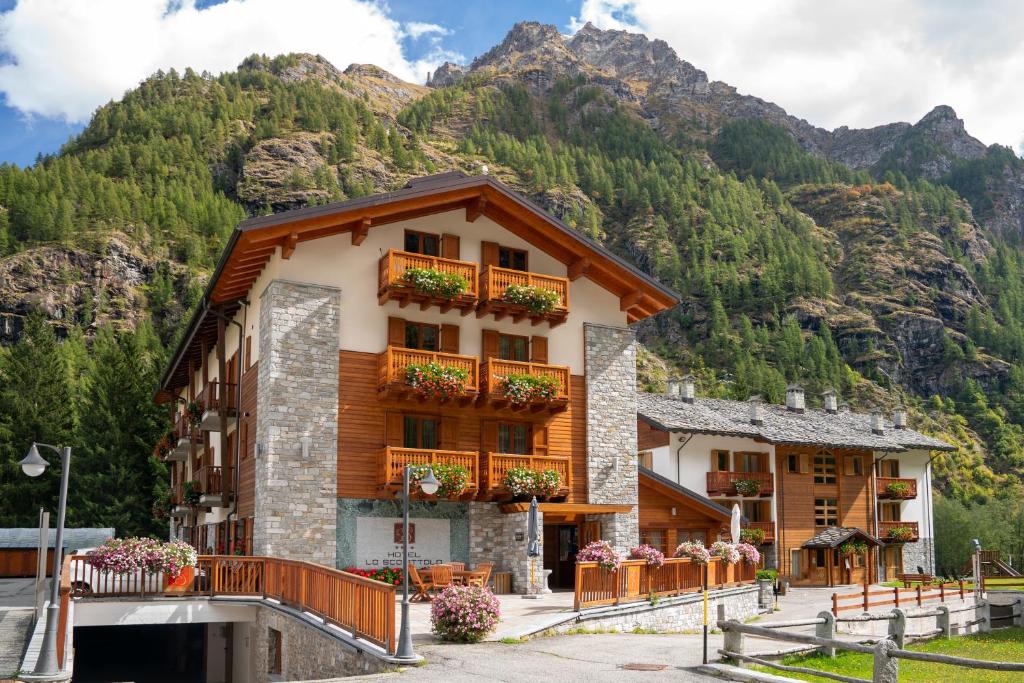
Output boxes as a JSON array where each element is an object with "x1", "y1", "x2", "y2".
[{"x1": 754, "y1": 629, "x2": 1024, "y2": 683}]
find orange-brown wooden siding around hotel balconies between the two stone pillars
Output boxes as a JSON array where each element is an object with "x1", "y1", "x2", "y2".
[{"x1": 338, "y1": 351, "x2": 587, "y2": 503}]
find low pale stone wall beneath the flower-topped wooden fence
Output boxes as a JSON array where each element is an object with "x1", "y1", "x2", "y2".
[{"x1": 554, "y1": 586, "x2": 760, "y2": 633}]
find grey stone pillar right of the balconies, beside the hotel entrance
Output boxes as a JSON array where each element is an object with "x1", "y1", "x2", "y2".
[{"x1": 584, "y1": 323, "x2": 640, "y2": 549}]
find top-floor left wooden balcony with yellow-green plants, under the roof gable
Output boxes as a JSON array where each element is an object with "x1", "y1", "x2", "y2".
[{"x1": 377, "y1": 249, "x2": 478, "y2": 315}]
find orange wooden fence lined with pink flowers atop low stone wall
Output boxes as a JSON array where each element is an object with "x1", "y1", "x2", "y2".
[{"x1": 574, "y1": 557, "x2": 758, "y2": 610}]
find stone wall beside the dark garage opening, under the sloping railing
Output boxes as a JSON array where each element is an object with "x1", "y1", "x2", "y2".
[{"x1": 249, "y1": 607, "x2": 390, "y2": 683}]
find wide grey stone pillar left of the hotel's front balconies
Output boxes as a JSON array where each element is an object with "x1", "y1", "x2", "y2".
[{"x1": 253, "y1": 280, "x2": 341, "y2": 566}]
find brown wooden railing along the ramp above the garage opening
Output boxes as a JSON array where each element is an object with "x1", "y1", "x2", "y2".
[{"x1": 61, "y1": 555, "x2": 396, "y2": 654}]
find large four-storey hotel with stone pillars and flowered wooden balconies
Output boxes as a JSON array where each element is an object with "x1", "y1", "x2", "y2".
[{"x1": 149, "y1": 173, "x2": 729, "y2": 591}]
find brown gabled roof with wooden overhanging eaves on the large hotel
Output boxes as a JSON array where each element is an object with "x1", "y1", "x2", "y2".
[{"x1": 161, "y1": 172, "x2": 679, "y2": 390}]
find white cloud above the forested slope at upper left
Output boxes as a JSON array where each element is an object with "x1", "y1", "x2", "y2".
[{"x1": 0, "y1": 0, "x2": 461, "y2": 122}]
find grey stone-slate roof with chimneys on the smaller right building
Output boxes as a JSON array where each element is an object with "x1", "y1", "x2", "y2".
[{"x1": 637, "y1": 392, "x2": 955, "y2": 452}]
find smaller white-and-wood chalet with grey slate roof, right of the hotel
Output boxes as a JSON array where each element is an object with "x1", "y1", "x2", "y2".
[{"x1": 637, "y1": 378, "x2": 953, "y2": 586}]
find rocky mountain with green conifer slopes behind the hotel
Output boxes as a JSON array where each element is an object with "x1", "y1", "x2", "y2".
[{"x1": 0, "y1": 24, "x2": 1024, "y2": 500}]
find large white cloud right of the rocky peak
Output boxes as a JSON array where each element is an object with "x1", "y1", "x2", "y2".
[{"x1": 570, "y1": 0, "x2": 1024, "y2": 147}]
